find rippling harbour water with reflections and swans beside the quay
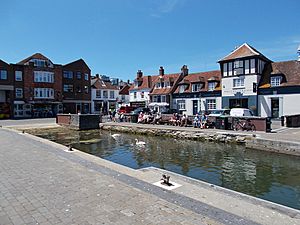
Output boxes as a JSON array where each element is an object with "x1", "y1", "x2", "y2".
[{"x1": 34, "y1": 131, "x2": 300, "y2": 209}]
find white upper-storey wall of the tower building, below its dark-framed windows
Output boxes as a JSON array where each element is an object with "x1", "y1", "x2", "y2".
[{"x1": 222, "y1": 75, "x2": 260, "y2": 97}]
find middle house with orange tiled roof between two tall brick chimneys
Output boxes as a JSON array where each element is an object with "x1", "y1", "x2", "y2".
[{"x1": 149, "y1": 65, "x2": 184, "y2": 112}]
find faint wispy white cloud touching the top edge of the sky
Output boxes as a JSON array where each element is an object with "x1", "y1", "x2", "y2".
[{"x1": 150, "y1": 0, "x2": 185, "y2": 18}]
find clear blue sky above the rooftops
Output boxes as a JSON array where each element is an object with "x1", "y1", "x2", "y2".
[{"x1": 0, "y1": 0, "x2": 300, "y2": 80}]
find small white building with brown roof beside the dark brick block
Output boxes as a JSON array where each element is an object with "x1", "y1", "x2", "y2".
[{"x1": 91, "y1": 76, "x2": 119, "y2": 114}]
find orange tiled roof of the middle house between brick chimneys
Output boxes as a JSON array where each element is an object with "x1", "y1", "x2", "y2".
[{"x1": 150, "y1": 73, "x2": 180, "y2": 95}]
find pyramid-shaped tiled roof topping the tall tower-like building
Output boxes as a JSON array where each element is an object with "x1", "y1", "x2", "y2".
[{"x1": 218, "y1": 43, "x2": 270, "y2": 62}]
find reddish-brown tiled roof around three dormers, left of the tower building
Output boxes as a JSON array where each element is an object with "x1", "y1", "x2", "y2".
[{"x1": 174, "y1": 70, "x2": 221, "y2": 93}]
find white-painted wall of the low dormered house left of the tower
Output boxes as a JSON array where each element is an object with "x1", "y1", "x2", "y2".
[{"x1": 173, "y1": 97, "x2": 222, "y2": 115}]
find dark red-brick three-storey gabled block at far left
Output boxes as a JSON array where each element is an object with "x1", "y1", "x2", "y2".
[{"x1": 0, "y1": 53, "x2": 90, "y2": 118}]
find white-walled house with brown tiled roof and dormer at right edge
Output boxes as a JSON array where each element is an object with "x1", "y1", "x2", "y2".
[{"x1": 258, "y1": 60, "x2": 300, "y2": 118}]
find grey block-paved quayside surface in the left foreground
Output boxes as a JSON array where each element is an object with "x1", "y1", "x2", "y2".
[{"x1": 0, "y1": 129, "x2": 219, "y2": 225}]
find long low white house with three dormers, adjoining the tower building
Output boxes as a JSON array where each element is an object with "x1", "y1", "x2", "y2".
[{"x1": 173, "y1": 70, "x2": 221, "y2": 115}]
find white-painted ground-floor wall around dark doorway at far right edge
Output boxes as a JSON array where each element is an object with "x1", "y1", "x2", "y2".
[{"x1": 258, "y1": 94, "x2": 300, "y2": 117}]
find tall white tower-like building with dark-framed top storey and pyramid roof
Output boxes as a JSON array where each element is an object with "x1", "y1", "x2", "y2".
[{"x1": 219, "y1": 43, "x2": 271, "y2": 114}]
